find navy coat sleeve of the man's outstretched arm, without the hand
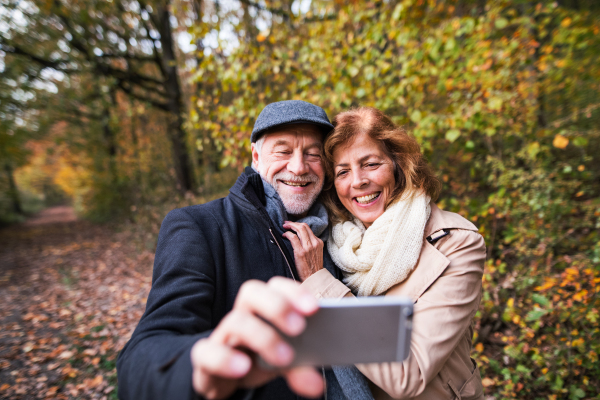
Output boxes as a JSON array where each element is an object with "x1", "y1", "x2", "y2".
[{"x1": 117, "y1": 209, "x2": 214, "y2": 399}]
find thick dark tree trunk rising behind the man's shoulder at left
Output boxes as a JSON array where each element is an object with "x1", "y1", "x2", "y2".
[{"x1": 157, "y1": 4, "x2": 195, "y2": 193}]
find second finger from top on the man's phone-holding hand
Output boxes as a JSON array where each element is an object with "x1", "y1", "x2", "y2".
[{"x1": 213, "y1": 311, "x2": 294, "y2": 367}]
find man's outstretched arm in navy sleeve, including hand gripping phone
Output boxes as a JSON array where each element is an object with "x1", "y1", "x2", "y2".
[{"x1": 117, "y1": 210, "x2": 323, "y2": 399}]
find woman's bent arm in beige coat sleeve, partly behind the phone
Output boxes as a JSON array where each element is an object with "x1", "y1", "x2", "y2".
[{"x1": 302, "y1": 230, "x2": 486, "y2": 398}]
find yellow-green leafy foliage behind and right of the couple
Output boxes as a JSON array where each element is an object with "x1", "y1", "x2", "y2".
[{"x1": 188, "y1": 5, "x2": 600, "y2": 400}]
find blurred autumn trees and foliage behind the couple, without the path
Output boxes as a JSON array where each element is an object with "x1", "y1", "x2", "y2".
[{"x1": 0, "y1": 0, "x2": 600, "y2": 399}]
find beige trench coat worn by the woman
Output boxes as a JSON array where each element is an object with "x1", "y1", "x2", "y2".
[{"x1": 302, "y1": 204, "x2": 486, "y2": 400}]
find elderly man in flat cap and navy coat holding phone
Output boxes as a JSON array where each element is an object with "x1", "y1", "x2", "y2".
[{"x1": 117, "y1": 101, "x2": 352, "y2": 399}]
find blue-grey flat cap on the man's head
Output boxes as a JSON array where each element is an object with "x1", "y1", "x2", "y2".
[{"x1": 250, "y1": 100, "x2": 333, "y2": 143}]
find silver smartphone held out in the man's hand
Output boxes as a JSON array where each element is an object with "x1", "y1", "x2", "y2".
[{"x1": 270, "y1": 297, "x2": 413, "y2": 366}]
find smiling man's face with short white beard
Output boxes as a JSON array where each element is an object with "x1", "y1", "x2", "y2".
[{"x1": 252, "y1": 124, "x2": 325, "y2": 216}]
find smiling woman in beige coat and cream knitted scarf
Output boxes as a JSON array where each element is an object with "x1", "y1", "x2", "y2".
[{"x1": 284, "y1": 107, "x2": 486, "y2": 400}]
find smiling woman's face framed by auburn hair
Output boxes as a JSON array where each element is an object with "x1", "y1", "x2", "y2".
[{"x1": 333, "y1": 134, "x2": 396, "y2": 228}]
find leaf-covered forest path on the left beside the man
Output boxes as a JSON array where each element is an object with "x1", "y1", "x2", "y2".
[{"x1": 0, "y1": 206, "x2": 154, "y2": 399}]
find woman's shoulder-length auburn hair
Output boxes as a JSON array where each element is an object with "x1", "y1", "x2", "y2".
[{"x1": 321, "y1": 107, "x2": 441, "y2": 222}]
